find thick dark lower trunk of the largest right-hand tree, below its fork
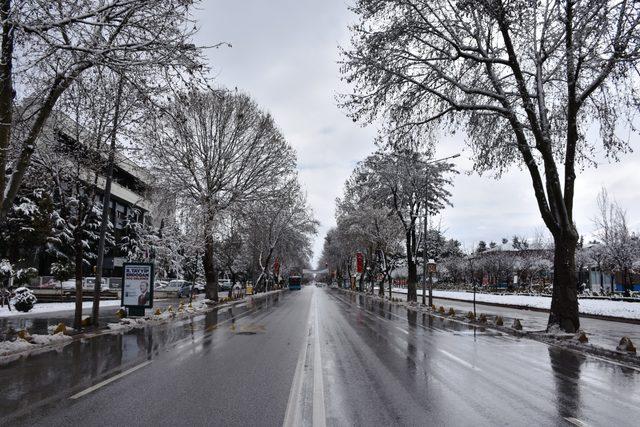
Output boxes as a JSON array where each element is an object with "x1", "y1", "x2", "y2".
[{"x1": 548, "y1": 230, "x2": 580, "y2": 333}]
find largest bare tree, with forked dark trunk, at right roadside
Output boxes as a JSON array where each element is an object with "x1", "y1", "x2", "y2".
[{"x1": 343, "y1": 0, "x2": 640, "y2": 332}]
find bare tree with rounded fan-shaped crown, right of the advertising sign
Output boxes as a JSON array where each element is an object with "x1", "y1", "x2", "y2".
[{"x1": 145, "y1": 90, "x2": 296, "y2": 301}]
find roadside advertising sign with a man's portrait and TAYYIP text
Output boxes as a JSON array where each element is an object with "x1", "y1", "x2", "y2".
[{"x1": 121, "y1": 263, "x2": 154, "y2": 316}]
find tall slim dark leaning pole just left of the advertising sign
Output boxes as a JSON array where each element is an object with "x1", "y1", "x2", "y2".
[{"x1": 91, "y1": 76, "x2": 124, "y2": 326}]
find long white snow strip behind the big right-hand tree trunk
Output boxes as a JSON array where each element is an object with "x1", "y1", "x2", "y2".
[{"x1": 394, "y1": 288, "x2": 640, "y2": 319}]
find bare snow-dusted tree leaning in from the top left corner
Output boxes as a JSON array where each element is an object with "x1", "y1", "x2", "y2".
[{"x1": 0, "y1": 0, "x2": 200, "y2": 221}]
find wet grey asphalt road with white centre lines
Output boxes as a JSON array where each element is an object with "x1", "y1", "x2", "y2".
[{"x1": 0, "y1": 287, "x2": 640, "y2": 426}]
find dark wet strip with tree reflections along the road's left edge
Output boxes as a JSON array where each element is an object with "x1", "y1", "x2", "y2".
[{"x1": 0, "y1": 294, "x2": 280, "y2": 416}]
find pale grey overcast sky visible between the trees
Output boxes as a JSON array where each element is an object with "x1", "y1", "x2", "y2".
[{"x1": 197, "y1": 0, "x2": 640, "y2": 268}]
